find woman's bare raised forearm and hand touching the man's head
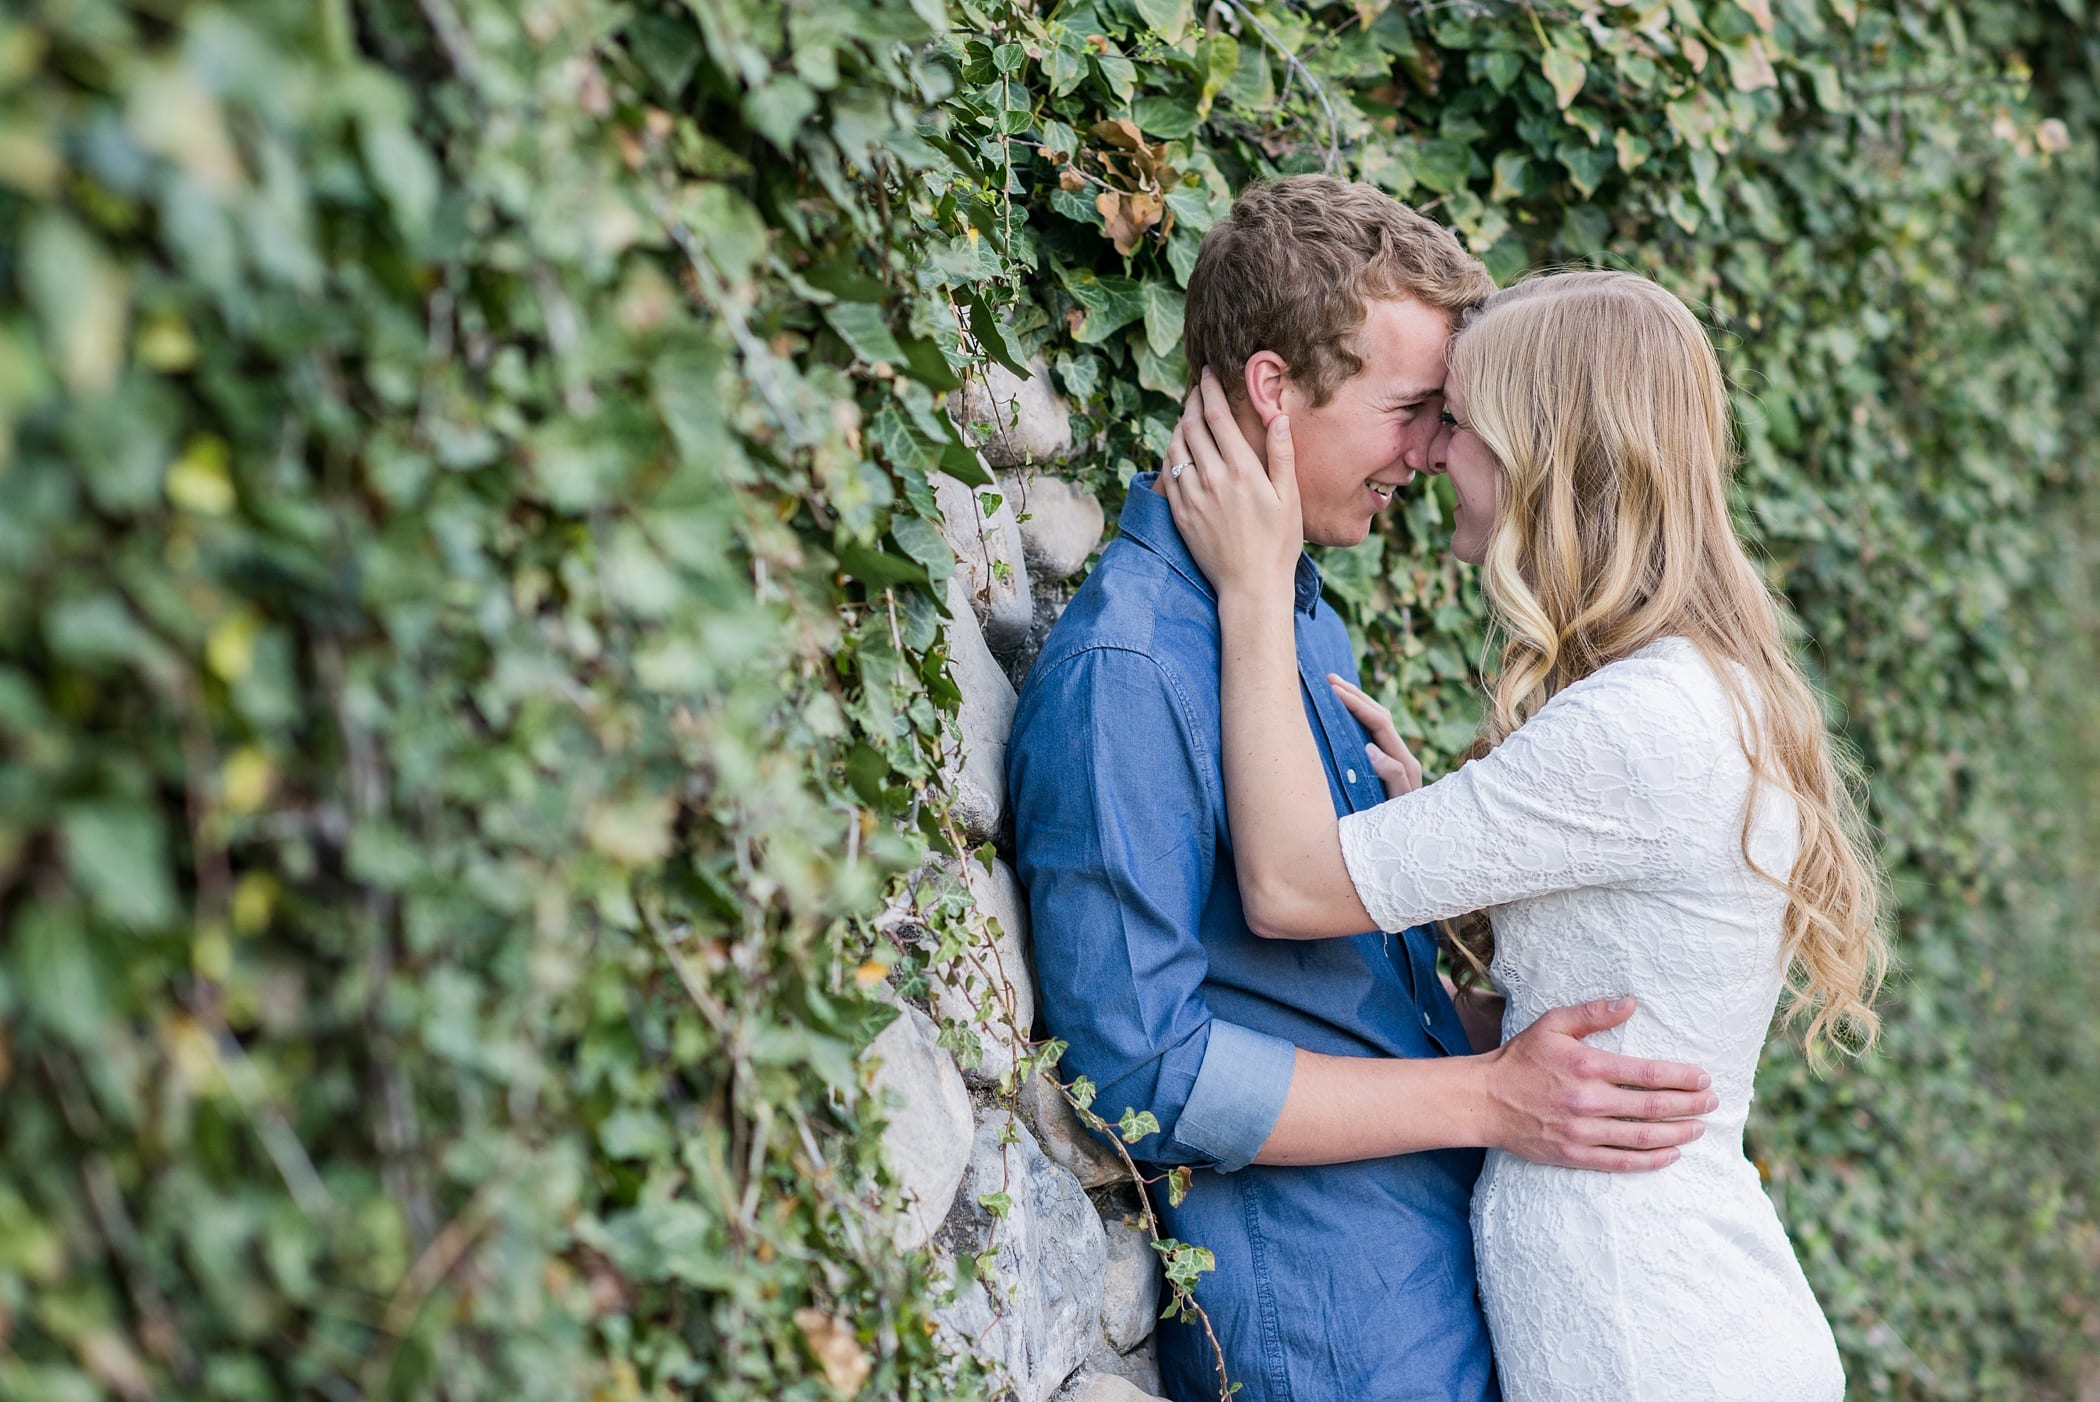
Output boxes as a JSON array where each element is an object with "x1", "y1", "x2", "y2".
[{"x1": 1161, "y1": 371, "x2": 1373, "y2": 938}]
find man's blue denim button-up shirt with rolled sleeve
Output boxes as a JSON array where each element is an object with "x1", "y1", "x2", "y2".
[{"x1": 1008, "y1": 476, "x2": 1495, "y2": 1402}]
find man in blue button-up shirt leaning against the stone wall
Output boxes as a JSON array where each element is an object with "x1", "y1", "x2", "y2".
[{"x1": 1008, "y1": 176, "x2": 1712, "y2": 1402}]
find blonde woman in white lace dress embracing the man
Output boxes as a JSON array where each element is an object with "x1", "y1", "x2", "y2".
[{"x1": 1168, "y1": 273, "x2": 1886, "y2": 1402}]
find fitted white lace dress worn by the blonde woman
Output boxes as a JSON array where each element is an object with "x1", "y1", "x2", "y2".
[{"x1": 1342, "y1": 638, "x2": 1844, "y2": 1402}]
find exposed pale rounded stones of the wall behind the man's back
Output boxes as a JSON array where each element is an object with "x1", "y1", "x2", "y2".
[{"x1": 867, "y1": 361, "x2": 1161, "y2": 1402}]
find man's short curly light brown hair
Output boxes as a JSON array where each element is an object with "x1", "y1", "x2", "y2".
[{"x1": 1182, "y1": 174, "x2": 1495, "y2": 405}]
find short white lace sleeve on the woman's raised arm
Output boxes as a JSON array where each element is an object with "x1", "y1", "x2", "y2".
[{"x1": 1342, "y1": 659, "x2": 1741, "y2": 930}]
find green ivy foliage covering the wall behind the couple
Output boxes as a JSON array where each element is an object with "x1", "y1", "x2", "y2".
[{"x1": 0, "y1": 0, "x2": 2100, "y2": 1402}]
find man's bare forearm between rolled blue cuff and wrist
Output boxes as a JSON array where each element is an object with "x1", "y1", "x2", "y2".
[{"x1": 1254, "y1": 1047, "x2": 1497, "y2": 1165}]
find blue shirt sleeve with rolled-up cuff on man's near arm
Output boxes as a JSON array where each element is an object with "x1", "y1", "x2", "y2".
[{"x1": 1008, "y1": 646, "x2": 1296, "y2": 1169}]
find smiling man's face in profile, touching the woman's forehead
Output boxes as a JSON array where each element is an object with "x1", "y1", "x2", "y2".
[{"x1": 1283, "y1": 298, "x2": 1451, "y2": 546}]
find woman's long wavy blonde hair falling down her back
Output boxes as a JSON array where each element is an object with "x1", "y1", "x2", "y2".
[{"x1": 1451, "y1": 273, "x2": 1888, "y2": 1049}]
